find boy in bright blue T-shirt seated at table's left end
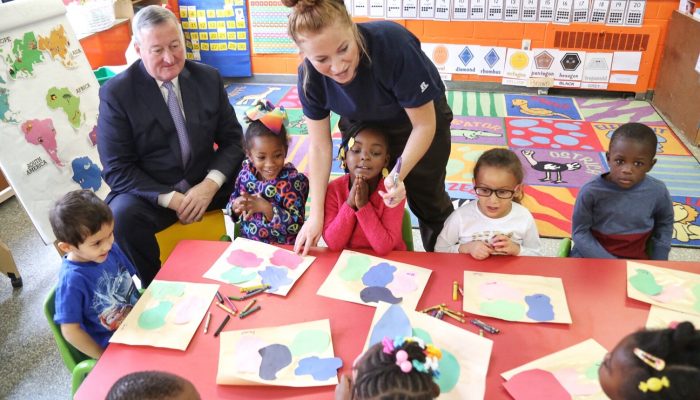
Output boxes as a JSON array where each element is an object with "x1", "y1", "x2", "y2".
[{"x1": 49, "y1": 190, "x2": 139, "y2": 358}]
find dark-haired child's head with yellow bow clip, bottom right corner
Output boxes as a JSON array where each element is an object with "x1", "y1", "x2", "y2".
[{"x1": 598, "y1": 322, "x2": 700, "y2": 400}]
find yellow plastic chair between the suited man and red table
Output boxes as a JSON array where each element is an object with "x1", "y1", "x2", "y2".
[{"x1": 156, "y1": 210, "x2": 226, "y2": 265}]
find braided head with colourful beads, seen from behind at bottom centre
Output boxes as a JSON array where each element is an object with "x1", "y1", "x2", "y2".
[{"x1": 335, "y1": 337, "x2": 442, "y2": 400}]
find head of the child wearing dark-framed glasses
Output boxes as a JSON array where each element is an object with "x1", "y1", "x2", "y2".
[{"x1": 474, "y1": 148, "x2": 524, "y2": 218}]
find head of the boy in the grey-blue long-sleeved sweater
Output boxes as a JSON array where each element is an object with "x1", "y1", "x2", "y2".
[{"x1": 606, "y1": 122, "x2": 658, "y2": 189}]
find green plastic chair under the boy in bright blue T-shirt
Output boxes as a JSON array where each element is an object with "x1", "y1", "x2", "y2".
[{"x1": 44, "y1": 287, "x2": 97, "y2": 394}]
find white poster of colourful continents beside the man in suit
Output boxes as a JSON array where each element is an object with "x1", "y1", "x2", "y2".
[{"x1": 0, "y1": 0, "x2": 109, "y2": 243}]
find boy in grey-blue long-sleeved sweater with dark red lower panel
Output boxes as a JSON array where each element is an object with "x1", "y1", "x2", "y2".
[{"x1": 571, "y1": 123, "x2": 673, "y2": 260}]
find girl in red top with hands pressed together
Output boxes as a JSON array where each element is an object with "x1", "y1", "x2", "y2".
[{"x1": 323, "y1": 125, "x2": 406, "y2": 255}]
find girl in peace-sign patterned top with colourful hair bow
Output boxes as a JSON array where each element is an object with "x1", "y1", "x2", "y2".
[{"x1": 226, "y1": 101, "x2": 309, "y2": 244}]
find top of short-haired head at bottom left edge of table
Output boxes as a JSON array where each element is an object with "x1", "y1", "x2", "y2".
[{"x1": 106, "y1": 371, "x2": 200, "y2": 400}]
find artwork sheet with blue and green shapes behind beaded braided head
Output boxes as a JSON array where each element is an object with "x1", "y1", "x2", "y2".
[{"x1": 364, "y1": 302, "x2": 493, "y2": 400}]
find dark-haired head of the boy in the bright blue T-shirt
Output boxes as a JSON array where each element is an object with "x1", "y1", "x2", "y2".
[{"x1": 49, "y1": 190, "x2": 114, "y2": 263}]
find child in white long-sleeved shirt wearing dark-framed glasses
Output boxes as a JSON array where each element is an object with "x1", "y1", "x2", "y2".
[{"x1": 435, "y1": 148, "x2": 542, "y2": 260}]
